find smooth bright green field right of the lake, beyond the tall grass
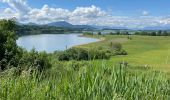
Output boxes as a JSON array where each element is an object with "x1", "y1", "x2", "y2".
[{"x1": 81, "y1": 35, "x2": 170, "y2": 72}]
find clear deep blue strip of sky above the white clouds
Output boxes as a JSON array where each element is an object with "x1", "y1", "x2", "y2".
[{"x1": 22, "y1": 0, "x2": 170, "y2": 16}]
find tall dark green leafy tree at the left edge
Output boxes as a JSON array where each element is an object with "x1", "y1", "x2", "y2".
[{"x1": 0, "y1": 20, "x2": 21, "y2": 70}]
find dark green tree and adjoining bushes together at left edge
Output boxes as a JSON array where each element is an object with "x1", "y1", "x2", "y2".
[{"x1": 0, "y1": 20, "x2": 50, "y2": 71}]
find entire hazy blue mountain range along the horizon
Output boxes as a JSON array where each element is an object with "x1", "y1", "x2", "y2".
[{"x1": 17, "y1": 21, "x2": 170, "y2": 30}]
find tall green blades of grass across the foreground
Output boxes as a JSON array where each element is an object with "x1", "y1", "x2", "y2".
[{"x1": 0, "y1": 61, "x2": 170, "y2": 100}]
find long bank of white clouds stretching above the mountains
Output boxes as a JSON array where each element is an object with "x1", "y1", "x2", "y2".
[{"x1": 0, "y1": 0, "x2": 170, "y2": 28}]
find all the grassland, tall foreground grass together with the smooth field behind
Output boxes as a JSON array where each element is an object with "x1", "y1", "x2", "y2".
[{"x1": 0, "y1": 35, "x2": 170, "y2": 100}]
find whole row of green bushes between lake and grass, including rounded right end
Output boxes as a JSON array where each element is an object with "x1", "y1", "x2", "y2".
[{"x1": 54, "y1": 42, "x2": 127, "y2": 61}]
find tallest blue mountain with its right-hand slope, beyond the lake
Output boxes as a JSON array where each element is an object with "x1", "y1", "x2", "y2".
[{"x1": 46, "y1": 21, "x2": 94, "y2": 29}]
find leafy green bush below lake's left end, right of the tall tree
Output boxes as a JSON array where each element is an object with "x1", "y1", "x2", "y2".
[{"x1": 18, "y1": 49, "x2": 51, "y2": 71}]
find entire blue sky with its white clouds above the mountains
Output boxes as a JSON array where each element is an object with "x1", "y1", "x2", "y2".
[{"x1": 0, "y1": 0, "x2": 170, "y2": 28}]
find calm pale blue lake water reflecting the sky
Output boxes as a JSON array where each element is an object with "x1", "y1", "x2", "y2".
[{"x1": 17, "y1": 34, "x2": 99, "y2": 53}]
